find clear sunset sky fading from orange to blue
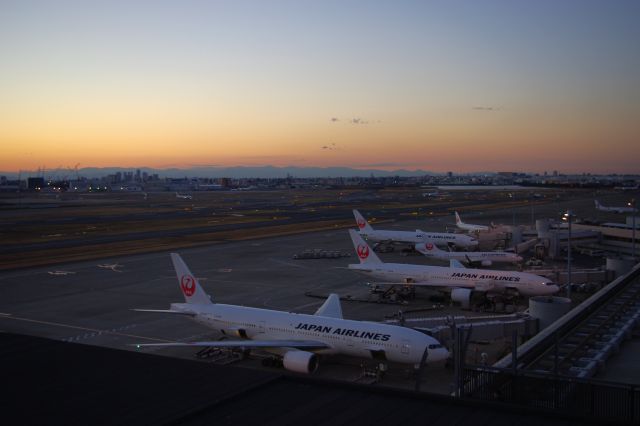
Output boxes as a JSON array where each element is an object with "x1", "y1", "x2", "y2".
[{"x1": 0, "y1": 0, "x2": 640, "y2": 173}]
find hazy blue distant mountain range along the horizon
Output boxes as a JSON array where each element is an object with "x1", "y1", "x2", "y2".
[{"x1": 0, "y1": 166, "x2": 441, "y2": 179}]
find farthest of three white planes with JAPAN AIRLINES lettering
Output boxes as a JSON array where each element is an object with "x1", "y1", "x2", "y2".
[{"x1": 353, "y1": 210, "x2": 478, "y2": 247}]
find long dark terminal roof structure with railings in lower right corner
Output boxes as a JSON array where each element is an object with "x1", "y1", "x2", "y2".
[{"x1": 455, "y1": 264, "x2": 640, "y2": 424}]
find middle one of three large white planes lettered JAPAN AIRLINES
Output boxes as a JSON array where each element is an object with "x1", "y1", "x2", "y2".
[{"x1": 349, "y1": 229, "x2": 558, "y2": 304}]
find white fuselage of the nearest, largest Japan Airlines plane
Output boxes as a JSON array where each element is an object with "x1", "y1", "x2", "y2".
[{"x1": 171, "y1": 303, "x2": 448, "y2": 364}]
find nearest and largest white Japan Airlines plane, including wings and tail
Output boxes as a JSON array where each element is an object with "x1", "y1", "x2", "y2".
[{"x1": 136, "y1": 253, "x2": 449, "y2": 373}]
